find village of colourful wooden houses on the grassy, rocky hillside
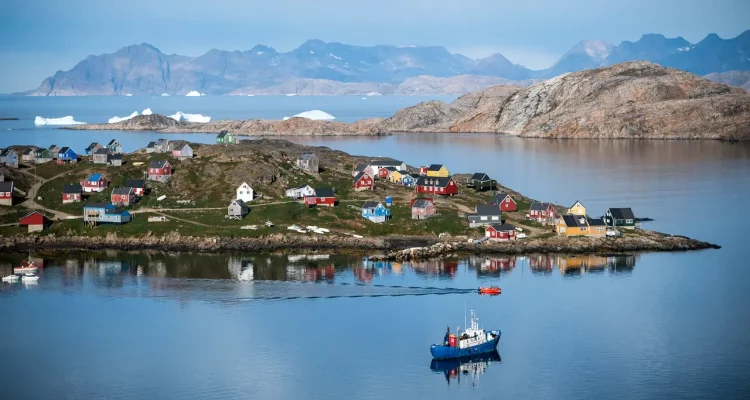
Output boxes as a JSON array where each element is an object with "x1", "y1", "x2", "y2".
[{"x1": 0, "y1": 132, "x2": 638, "y2": 248}]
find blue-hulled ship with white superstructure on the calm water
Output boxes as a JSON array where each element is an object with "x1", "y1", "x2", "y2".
[{"x1": 430, "y1": 311, "x2": 500, "y2": 360}]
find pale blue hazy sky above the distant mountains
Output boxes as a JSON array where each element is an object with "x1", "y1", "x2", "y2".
[{"x1": 0, "y1": 0, "x2": 750, "y2": 93}]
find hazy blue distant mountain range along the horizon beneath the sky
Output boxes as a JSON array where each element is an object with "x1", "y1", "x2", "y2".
[{"x1": 23, "y1": 30, "x2": 750, "y2": 96}]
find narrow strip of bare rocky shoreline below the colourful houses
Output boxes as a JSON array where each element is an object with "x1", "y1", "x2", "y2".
[{"x1": 0, "y1": 231, "x2": 720, "y2": 261}]
